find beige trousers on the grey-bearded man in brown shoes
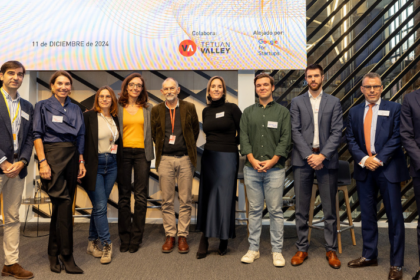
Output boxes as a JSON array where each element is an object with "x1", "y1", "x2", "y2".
[{"x1": 159, "y1": 156, "x2": 194, "y2": 237}]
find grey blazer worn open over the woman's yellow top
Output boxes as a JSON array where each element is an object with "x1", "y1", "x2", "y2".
[{"x1": 118, "y1": 103, "x2": 155, "y2": 161}]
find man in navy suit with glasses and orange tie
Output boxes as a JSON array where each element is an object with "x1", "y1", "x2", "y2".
[{"x1": 346, "y1": 73, "x2": 409, "y2": 279}]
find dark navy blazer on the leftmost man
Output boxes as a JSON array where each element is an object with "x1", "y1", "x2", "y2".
[{"x1": 0, "y1": 94, "x2": 34, "y2": 179}]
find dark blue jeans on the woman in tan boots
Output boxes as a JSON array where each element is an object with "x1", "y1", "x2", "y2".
[{"x1": 87, "y1": 154, "x2": 117, "y2": 245}]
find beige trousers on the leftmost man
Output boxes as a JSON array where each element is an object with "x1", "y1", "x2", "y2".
[{"x1": 0, "y1": 174, "x2": 25, "y2": 265}]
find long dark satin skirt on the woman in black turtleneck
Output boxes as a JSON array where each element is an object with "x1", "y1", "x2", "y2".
[{"x1": 197, "y1": 150, "x2": 239, "y2": 239}]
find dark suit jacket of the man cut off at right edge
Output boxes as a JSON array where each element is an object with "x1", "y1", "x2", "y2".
[{"x1": 400, "y1": 90, "x2": 420, "y2": 177}]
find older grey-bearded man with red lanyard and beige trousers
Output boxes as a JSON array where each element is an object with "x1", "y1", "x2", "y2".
[{"x1": 151, "y1": 78, "x2": 200, "y2": 253}]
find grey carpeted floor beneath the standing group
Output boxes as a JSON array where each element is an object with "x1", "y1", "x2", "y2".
[{"x1": 0, "y1": 224, "x2": 419, "y2": 280}]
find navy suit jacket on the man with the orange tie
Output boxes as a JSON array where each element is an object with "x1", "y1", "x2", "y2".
[{"x1": 346, "y1": 99, "x2": 410, "y2": 183}]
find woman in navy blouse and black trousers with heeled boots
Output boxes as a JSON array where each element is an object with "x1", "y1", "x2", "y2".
[{"x1": 33, "y1": 71, "x2": 86, "y2": 274}]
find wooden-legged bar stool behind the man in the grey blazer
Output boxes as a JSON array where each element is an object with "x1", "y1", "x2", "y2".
[{"x1": 308, "y1": 160, "x2": 356, "y2": 254}]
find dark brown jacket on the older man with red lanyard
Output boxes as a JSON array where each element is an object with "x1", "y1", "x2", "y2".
[{"x1": 152, "y1": 100, "x2": 200, "y2": 170}]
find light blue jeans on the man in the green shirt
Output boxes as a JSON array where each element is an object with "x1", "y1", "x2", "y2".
[{"x1": 244, "y1": 166, "x2": 285, "y2": 253}]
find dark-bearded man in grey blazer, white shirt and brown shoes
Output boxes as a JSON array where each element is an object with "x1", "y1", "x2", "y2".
[{"x1": 290, "y1": 64, "x2": 343, "y2": 268}]
